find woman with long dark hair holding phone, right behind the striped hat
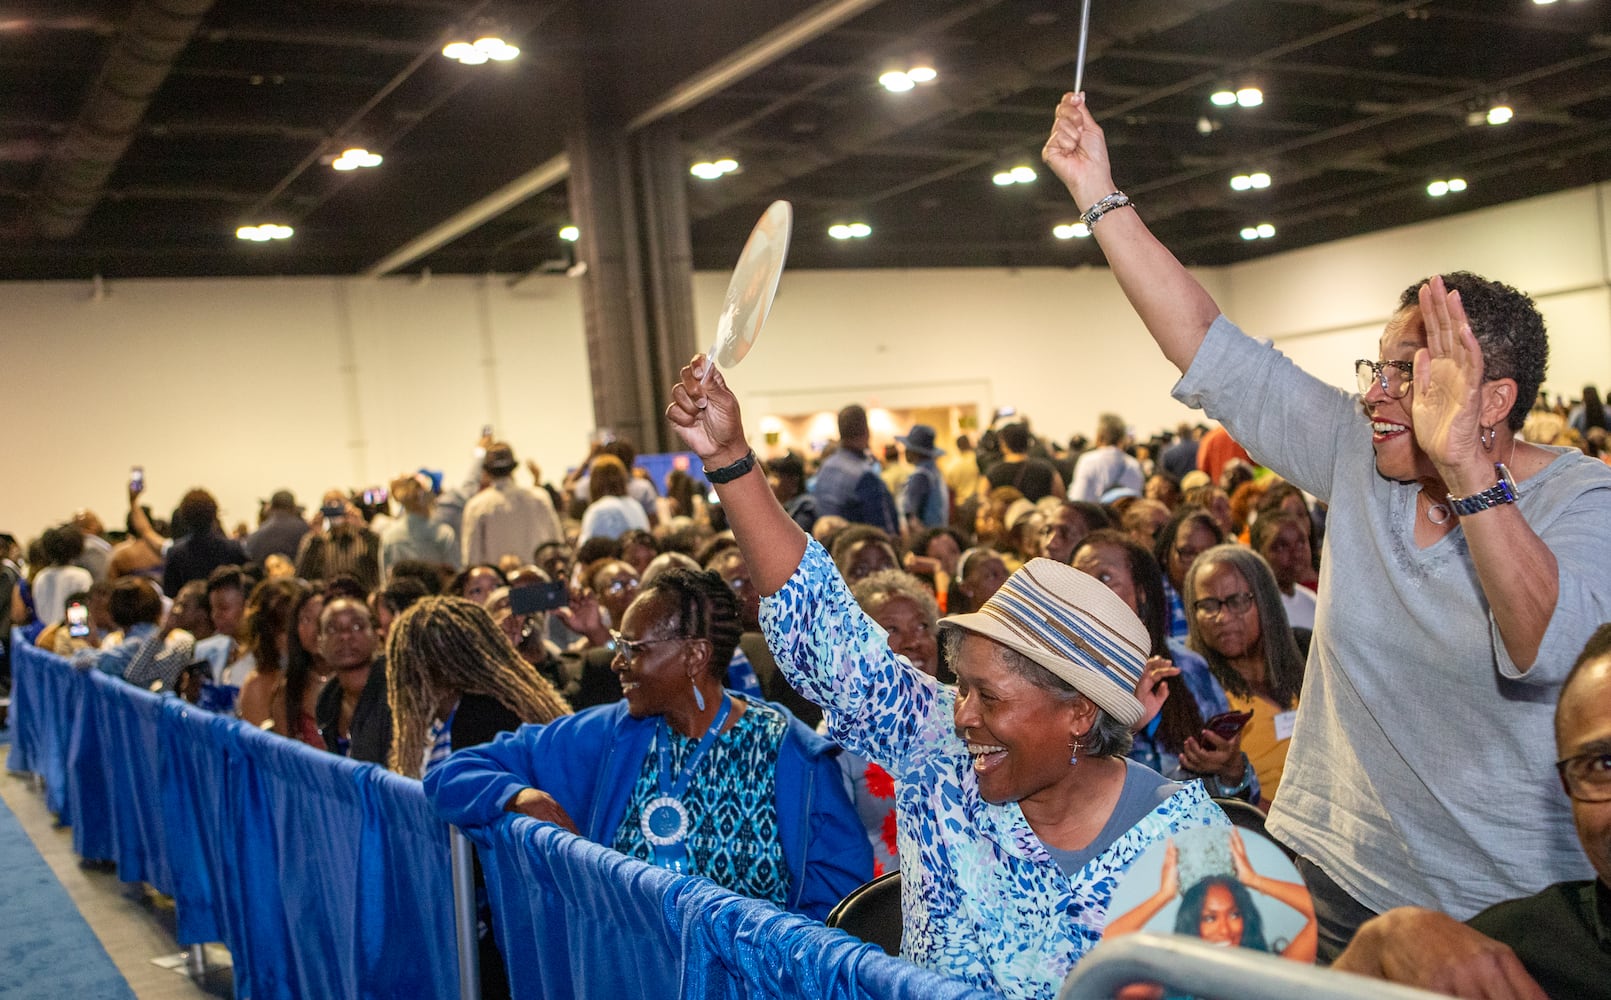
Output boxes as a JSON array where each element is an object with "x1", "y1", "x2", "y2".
[{"x1": 1073, "y1": 530, "x2": 1260, "y2": 802}]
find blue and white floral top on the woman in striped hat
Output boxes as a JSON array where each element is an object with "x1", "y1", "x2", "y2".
[{"x1": 760, "y1": 541, "x2": 1228, "y2": 998}]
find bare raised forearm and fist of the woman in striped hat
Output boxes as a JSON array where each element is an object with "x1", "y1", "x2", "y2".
[{"x1": 665, "y1": 354, "x2": 806, "y2": 596}]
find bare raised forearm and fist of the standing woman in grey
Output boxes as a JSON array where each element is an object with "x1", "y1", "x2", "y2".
[{"x1": 1041, "y1": 93, "x2": 1220, "y2": 372}]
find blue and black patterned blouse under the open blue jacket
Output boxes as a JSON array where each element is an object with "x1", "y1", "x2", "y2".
[{"x1": 612, "y1": 700, "x2": 789, "y2": 907}]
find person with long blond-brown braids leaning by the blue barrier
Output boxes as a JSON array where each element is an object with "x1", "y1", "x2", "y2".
[{"x1": 387, "y1": 597, "x2": 570, "y2": 778}]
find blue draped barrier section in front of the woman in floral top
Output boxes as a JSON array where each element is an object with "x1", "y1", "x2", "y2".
[{"x1": 474, "y1": 816, "x2": 988, "y2": 1000}]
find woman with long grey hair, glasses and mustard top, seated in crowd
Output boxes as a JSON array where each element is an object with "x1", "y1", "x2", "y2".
[{"x1": 1182, "y1": 544, "x2": 1303, "y2": 810}]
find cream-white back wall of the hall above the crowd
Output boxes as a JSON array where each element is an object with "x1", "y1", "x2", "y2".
[{"x1": 0, "y1": 185, "x2": 1611, "y2": 535}]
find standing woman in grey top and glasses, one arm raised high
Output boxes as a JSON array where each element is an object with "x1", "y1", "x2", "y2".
[{"x1": 1041, "y1": 95, "x2": 1611, "y2": 960}]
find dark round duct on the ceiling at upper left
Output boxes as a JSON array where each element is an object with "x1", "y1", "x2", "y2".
[{"x1": 29, "y1": 0, "x2": 214, "y2": 240}]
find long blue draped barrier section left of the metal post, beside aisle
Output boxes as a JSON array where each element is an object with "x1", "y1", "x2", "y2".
[{"x1": 8, "y1": 644, "x2": 458, "y2": 1000}]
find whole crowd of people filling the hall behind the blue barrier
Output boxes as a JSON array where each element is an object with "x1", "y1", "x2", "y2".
[{"x1": 0, "y1": 87, "x2": 1611, "y2": 997}]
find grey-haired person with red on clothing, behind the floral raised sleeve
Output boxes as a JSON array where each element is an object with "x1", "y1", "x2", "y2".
[{"x1": 839, "y1": 570, "x2": 939, "y2": 876}]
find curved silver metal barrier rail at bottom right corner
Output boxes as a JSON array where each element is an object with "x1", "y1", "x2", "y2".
[{"x1": 1057, "y1": 934, "x2": 1456, "y2": 1000}]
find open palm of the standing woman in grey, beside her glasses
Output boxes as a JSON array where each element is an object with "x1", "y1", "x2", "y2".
[{"x1": 1410, "y1": 277, "x2": 1493, "y2": 488}]
